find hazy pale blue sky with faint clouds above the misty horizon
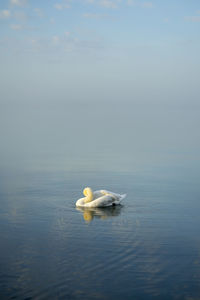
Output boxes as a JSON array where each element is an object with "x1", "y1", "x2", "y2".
[{"x1": 0, "y1": 0, "x2": 200, "y2": 100}]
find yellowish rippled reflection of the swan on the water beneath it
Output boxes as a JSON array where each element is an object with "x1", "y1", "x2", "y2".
[{"x1": 77, "y1": 205, "x2": 122, "y2": 222}]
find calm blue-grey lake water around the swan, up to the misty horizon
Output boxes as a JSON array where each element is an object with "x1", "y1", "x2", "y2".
[{"x1": 0, "y1": 100, "x2": 200, "y2": 300}]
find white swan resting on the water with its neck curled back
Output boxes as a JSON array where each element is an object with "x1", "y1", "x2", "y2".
[{"x1": 76, "y1": 187, "x2": 126, "y2": 208}]
